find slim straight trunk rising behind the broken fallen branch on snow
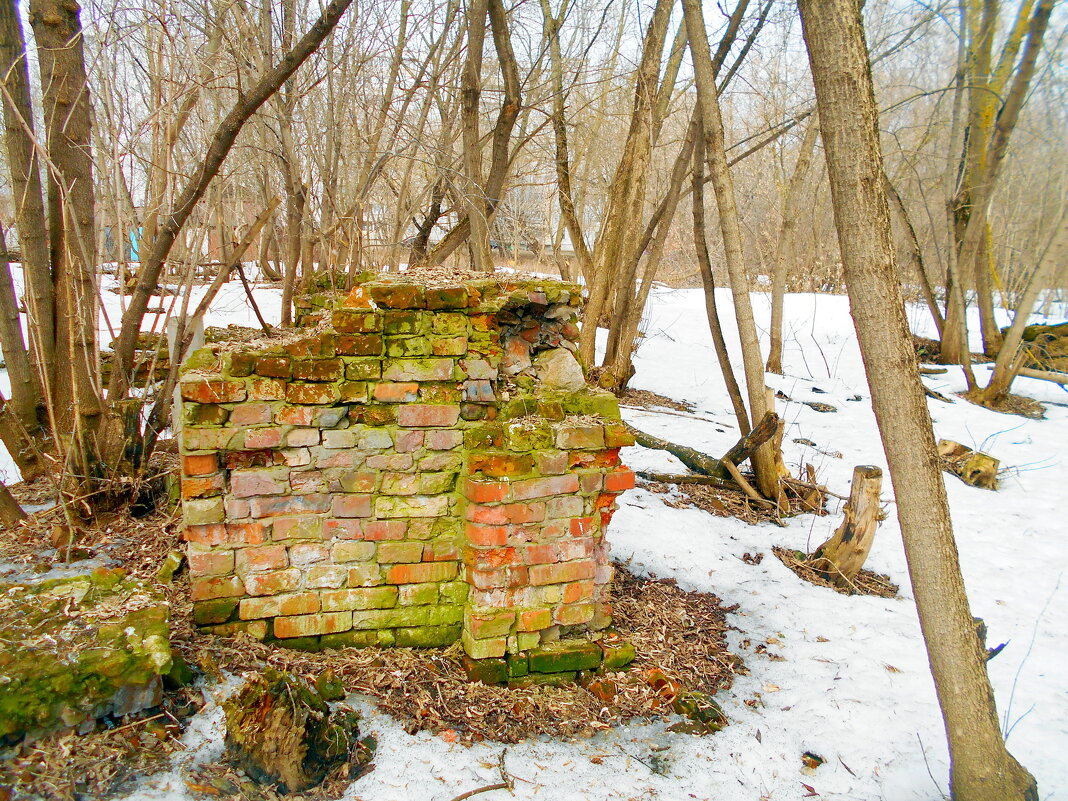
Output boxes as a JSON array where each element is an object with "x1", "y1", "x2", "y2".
[{"x1": 682, "y1": 0, "x2": 786, "y2": 500}]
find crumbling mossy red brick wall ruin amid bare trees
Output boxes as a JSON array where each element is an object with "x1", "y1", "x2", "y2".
[{"x1": 178, "y1": 276, "x2": 633, "y2": 681}]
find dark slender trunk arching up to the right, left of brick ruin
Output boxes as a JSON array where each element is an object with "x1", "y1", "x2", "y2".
[{"x1": 108, "y1": 0, "x2": 352, "y2": 399}]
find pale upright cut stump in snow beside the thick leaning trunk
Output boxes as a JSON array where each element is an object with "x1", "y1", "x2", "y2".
[{"x1": 810, "y1": 465, "x2": 882, "y2": 587}]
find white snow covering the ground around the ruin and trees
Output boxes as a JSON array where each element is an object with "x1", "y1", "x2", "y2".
[{"x1": 0, "y1": 273, "x2": 1068, "y2": 801}]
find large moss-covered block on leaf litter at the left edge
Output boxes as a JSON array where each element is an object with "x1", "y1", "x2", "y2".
[{"x1": 0, "y1": 568, "x2": 172, "y2": 739}]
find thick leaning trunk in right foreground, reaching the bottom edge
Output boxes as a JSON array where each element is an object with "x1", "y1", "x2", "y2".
[{"x1": 799, "y1": 0, "x2": 1038, "y2": 801}]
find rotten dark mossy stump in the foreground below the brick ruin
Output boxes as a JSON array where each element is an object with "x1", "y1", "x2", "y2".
[{"x1": 222, "y1": 668, "x2": 372, "y2": 794}]
